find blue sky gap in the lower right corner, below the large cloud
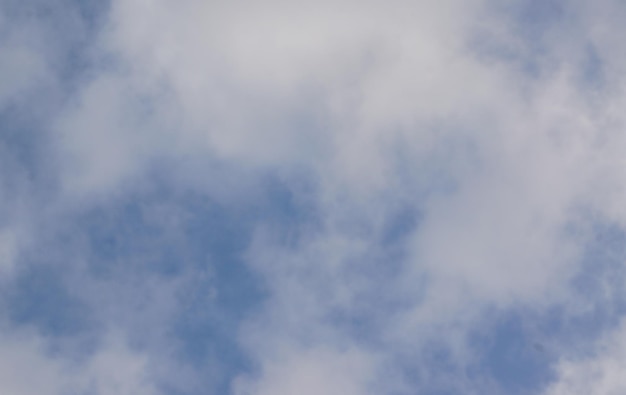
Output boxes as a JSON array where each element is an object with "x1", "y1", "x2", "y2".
[{"x1": 458, "y1": 220, "x2": 626, "y2": 394}]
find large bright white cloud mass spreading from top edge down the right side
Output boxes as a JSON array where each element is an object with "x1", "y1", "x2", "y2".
[{"x1": 86, "y1": 1, "x2": 623, "y2": 393}]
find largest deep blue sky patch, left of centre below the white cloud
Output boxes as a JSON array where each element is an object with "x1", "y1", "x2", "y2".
[{"x1": 6, "y1": 165, "x2": 326, "y2": 393}]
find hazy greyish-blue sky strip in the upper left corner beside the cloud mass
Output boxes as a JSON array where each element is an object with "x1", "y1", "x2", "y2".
[{"x1": 0, "y1": 0, "x2": 108, "y2": 193}]
